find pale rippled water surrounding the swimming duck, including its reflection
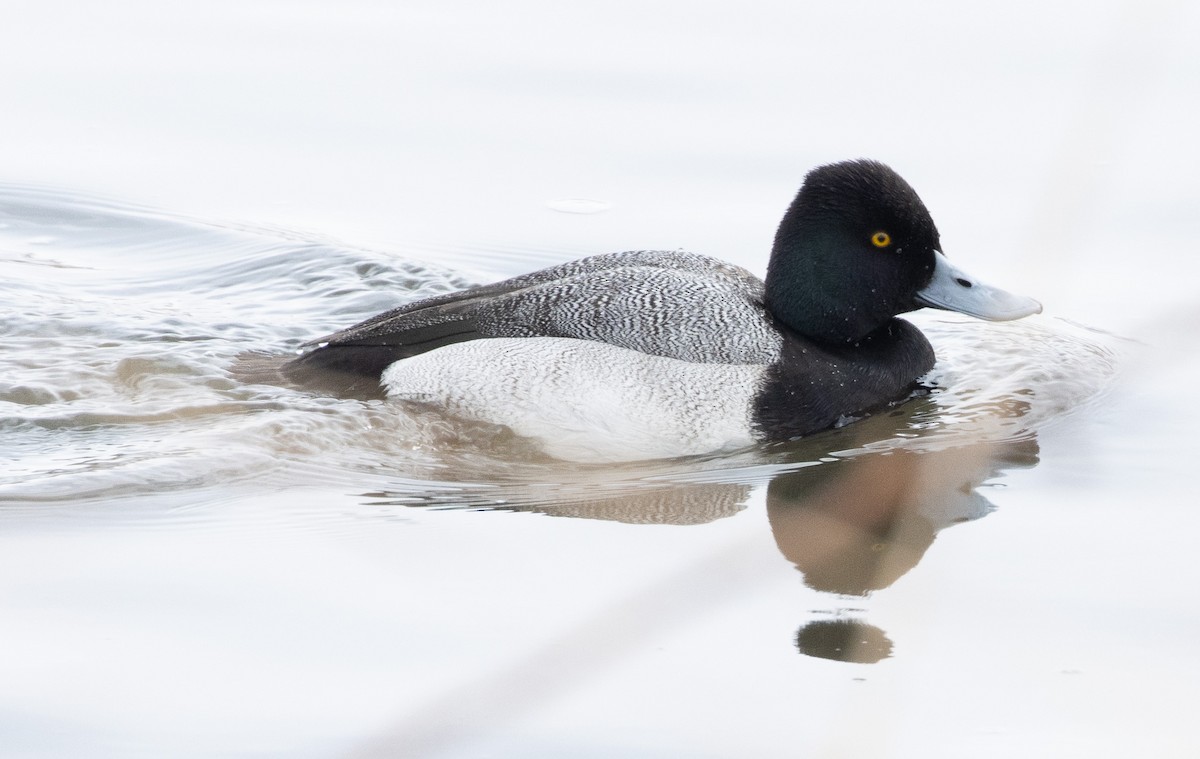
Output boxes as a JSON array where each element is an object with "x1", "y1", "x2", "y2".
[{"x1": 0, "y1": 2, "x2": 1200, "y2": 758}]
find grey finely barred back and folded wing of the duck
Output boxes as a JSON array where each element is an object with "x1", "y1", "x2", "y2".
[{"x1": 276, "y1": 253, "x2": 779, "y2": 383}]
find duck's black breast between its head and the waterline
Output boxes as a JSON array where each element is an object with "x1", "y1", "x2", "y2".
[{"x1": 752, "y1": 318, "x2": 935, "y2": 441}]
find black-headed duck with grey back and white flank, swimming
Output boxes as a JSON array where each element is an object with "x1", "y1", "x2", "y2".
[{"x1": 267, "y1": 160, "x2": 1042, "y2": 461}]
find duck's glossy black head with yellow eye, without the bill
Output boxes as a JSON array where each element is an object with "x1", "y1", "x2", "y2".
[{"x1": 767, "y1": 161, "x2": 941, "y2": 342}]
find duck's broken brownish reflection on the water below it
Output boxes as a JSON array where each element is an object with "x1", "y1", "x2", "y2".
[{"x1": 365, "y1": 404, "x2": 1038, "y2": 662}]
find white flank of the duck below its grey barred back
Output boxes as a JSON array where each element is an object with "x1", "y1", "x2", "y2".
[{"x1": 382, "y1": 337, "x2": 766, "y2": 461}]
